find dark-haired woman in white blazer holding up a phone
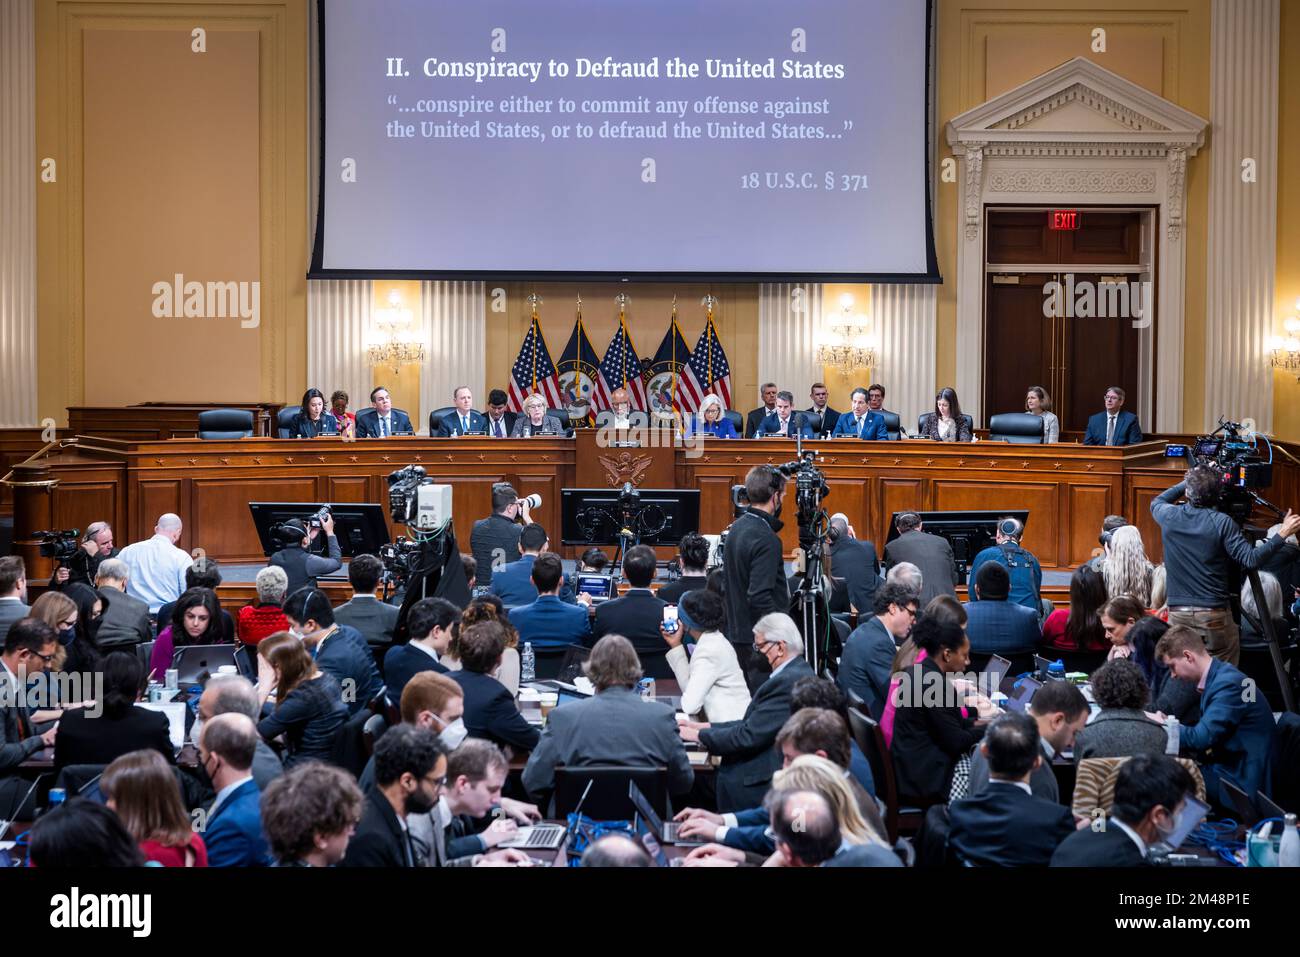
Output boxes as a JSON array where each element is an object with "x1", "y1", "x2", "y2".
[{"x1": 660, "y1": 588, "x2": 749, "y2": 722}]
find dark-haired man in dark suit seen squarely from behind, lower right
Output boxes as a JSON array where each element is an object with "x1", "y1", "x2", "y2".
[{"x1": 948, "y1": 713, "x2": 1074, "y2": 867}]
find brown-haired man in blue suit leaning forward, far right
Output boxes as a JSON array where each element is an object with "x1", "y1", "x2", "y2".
[{"x1": 1156, "y1": 624, "x2": 1277, "y2": 807}]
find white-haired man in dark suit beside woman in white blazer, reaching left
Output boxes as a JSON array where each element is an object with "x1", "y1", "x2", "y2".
[{"x1": 680, "y1": 612, "x2": 813, "y2": 813}]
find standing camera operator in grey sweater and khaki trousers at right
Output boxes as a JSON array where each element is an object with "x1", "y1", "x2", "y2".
[{"x1": 1151, "y1": 465, "x2": 1300, "y2": 667}]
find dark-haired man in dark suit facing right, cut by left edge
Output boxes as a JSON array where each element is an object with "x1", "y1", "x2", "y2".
[{"x1": 0, "y1": 621, "x2": 59, "y2": 820}]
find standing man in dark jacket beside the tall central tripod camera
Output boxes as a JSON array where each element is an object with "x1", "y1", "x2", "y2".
[{"x1": 723, "y1": 465, "x2": 790, "y2": 690}]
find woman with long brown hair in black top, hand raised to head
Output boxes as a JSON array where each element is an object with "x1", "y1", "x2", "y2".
[{"x1": 257, "y1": 632, "x2": 347, "y2": 768}]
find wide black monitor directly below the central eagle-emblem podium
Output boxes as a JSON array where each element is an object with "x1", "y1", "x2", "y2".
[{"x1": 560, "y1": 489, "x2": 699, "y2": 545}]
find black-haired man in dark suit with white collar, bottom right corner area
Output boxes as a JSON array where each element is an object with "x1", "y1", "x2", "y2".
[{"x1": 1052, "y1": 754, "x2": 1195, "y2": 867}]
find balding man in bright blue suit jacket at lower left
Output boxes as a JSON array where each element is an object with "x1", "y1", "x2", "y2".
[{"x1": 199, "y1": 711, "x2": 270, "y2": 867}]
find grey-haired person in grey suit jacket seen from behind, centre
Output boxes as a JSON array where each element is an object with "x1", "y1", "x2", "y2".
[{"x1": 524, "y1": 635, "x2": 696, "y2": 798}]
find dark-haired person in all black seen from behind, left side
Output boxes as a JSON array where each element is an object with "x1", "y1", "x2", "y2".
[{"x1": 55, "y1": 651, "x2": 176, "y2": 770}]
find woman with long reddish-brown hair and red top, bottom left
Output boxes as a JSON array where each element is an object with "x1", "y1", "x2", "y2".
[{"x1": 99, "y1": 750, "x2": 208, "y2": 867}]
